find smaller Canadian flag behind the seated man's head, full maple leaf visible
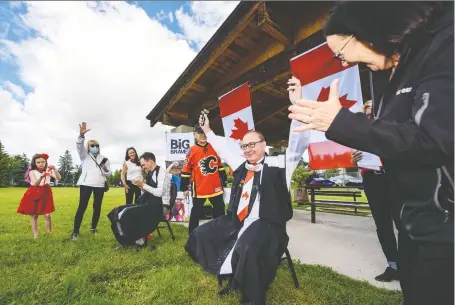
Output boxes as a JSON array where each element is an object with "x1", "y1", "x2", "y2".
[{"x1": 218, "y1": 82, "x2": 254, "y2": 155}]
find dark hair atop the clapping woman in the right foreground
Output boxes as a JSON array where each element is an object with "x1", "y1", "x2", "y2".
[{"x1": 324, "y1": 1, "x2": 453, "y2": 57}]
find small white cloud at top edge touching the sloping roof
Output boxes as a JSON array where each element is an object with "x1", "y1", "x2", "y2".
[{"x1": 175, "y1": 1, "x2": 239, "y2": 49}]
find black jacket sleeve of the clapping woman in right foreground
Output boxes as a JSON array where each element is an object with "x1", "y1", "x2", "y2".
[{"x1": 326, "y1": 43, "x2": 454, "y2": 166}]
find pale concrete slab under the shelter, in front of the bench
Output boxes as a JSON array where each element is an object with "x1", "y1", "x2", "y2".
[{"x1": 287, "y1": 210, "x2": 400, "y2": 290}]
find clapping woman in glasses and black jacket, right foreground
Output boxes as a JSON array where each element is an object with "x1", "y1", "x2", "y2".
[{"x1": 289, "y1": 1, "x2": 454, "y2": 305}]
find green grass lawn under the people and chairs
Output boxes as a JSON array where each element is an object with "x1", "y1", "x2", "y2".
[{"x1": 0, "y1": 188, "x2": 402, "y2": 305}]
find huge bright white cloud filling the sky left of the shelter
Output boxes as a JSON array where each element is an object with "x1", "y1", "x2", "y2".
[{"x1": 0, "y1": 1, "x2": 235, "y2": 169}]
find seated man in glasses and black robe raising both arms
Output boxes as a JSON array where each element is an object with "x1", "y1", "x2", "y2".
[{"x1": 185, "y1": 108, "x2": 309, "y2": 305}]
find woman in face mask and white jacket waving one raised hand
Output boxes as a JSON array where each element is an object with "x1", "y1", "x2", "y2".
[{"x1": 71, "y1": 122, "x2": 112, "y2": 240}]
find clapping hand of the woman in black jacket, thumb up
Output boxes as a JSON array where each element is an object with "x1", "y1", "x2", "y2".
[{"x1": 289, "y1": 79, "x2": 342, "y2": 132}]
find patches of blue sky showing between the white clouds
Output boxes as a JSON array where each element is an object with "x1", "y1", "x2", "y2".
[{"x1": 0, "y1": 1, "x2": 192, "y2": 101}]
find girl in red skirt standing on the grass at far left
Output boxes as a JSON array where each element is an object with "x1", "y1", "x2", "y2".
[{"x1": 17, "y1": 154, "x2": 60, "y2": 238}]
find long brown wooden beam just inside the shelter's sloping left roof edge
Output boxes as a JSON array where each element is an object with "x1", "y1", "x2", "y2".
[{"x1": 166, "y1": 3, "x2": 259, "y2": 114}]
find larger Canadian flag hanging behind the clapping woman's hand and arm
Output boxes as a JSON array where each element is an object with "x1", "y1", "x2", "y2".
[{"x1": 291, "y1": 43, "x2": 363, "y2": 170}]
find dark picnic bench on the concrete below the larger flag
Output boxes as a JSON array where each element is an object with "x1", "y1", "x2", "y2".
[{"x1": 297, "y1": 186, "x2": 368, "y2": 223}]
